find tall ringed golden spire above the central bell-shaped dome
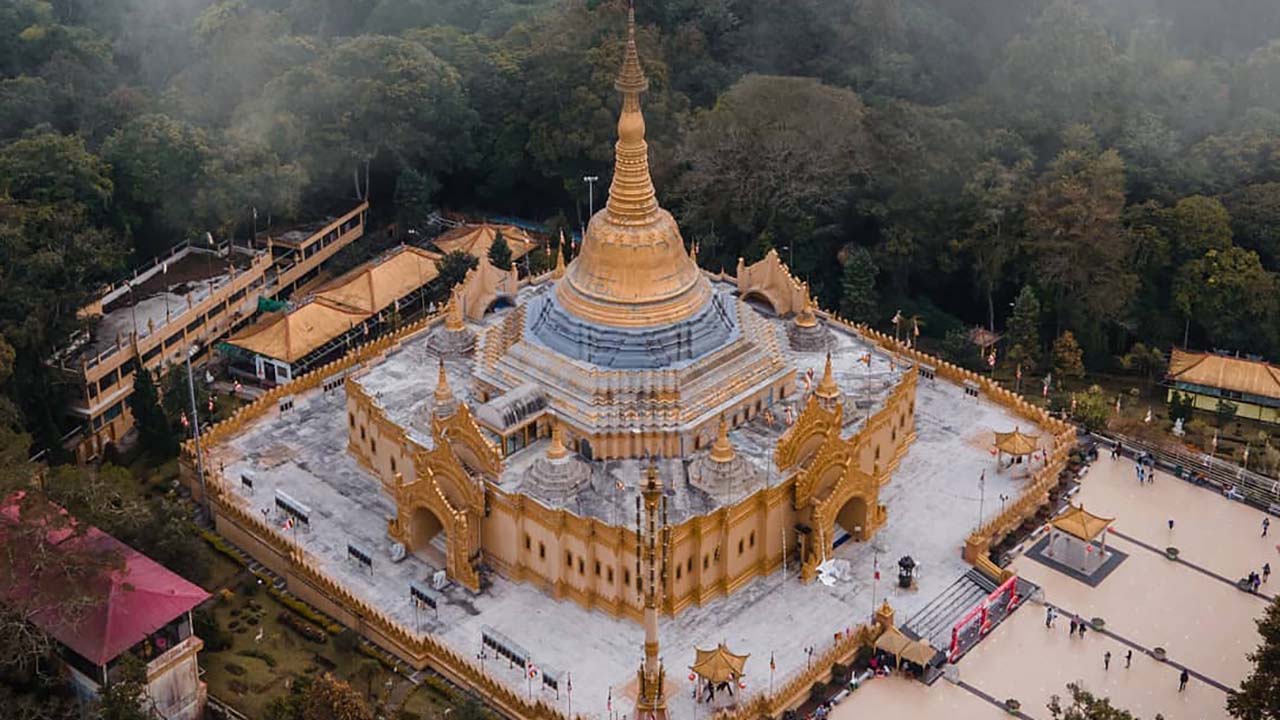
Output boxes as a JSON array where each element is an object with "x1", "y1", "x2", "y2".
[{"x1": 605, "y1": 3, "x2": 658, "y2": 224}]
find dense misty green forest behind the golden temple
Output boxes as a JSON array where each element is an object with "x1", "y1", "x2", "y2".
[{"x1": 0, "y1": 0, "x2": 1280, "y2": 448}]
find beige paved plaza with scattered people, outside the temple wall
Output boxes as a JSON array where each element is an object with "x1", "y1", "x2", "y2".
[{"x1": 835, "y1": 455, "x2": 1280, "y2": 720}]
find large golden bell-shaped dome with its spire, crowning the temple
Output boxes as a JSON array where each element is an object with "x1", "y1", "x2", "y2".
[{"x1": 557, "y1": 2, "x2": 712, "y2": 328}]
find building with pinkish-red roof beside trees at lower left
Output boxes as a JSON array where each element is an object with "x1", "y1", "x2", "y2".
[{"x1": 0, "y1": 496, "x2": 210, "y2": 720}]
